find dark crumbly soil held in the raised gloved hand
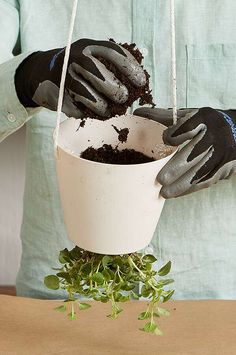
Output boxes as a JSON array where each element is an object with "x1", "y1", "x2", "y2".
[{"x1": 77, "y1": 39, "x2": 155, "y2": 120}]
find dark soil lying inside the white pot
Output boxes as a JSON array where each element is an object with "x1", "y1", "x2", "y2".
[{"x1": 80, "y1": 144, "x2": 155, "y2": 165}]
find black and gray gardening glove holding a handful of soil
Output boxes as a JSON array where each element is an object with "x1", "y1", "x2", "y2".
[{"x1": 15, "y1": 38, "x2": 146, "y2": 118}]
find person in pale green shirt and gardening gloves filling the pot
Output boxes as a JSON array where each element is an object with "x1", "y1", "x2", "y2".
[{"x1": 0, "y1": 0, "x2": 236, "y2": 299}]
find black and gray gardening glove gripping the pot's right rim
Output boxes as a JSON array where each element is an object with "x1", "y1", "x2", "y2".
[{"x1": 134, "y1": 107, "x2": 236, "y2": 198}]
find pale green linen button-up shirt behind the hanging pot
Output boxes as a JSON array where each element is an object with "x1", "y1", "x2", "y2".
[{"x1": 0, "y1": 0, "x2": 236, "y2": 299}]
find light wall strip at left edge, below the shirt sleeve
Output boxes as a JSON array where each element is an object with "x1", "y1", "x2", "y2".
[{"x1": 0, "y1": 128, "x2": 25, "y2": 285}]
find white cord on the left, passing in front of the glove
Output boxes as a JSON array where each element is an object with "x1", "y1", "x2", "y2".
[{"x1": 54, "y1": 0, "x2": 78, "y2": 157}]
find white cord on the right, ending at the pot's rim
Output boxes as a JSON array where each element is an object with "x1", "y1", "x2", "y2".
[{"x1": 170, "y1": 0, "x2": 177, "y2": 124}]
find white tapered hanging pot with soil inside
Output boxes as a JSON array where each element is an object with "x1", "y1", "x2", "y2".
[{"x1": 56, "y1": 115, "x2": 174, "y2": 255}]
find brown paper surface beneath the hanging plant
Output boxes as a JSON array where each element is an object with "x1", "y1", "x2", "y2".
[{"x1": 0, "y1": 296, "x2": 236, "y2": 355}]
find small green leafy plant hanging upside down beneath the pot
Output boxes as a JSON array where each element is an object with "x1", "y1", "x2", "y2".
[{"x1": 44, "y1": 246, "x2": 174, "y2": 335}]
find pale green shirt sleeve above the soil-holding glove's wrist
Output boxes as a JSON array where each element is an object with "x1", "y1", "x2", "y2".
[{"x1": 0, "y1": 0, "x2": 39, "y2": 142}]
